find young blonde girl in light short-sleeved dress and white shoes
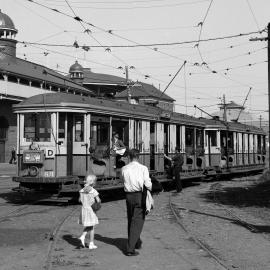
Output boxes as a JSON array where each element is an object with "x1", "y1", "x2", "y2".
[{"x1": 79, "y1": 174, "x2": 100, "y2": 249}]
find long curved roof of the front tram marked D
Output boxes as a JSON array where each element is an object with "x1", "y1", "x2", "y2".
[{"x1": 13, "y1": 93, "x2": 204, "y2": 126}]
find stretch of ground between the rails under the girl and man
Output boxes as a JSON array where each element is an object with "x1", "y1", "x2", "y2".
[{"x1": 52, "y1": 192, "x2": 224, "y2": 270}]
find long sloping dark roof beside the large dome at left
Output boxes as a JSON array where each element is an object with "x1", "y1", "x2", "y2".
[{"x1": 0, "y1": 58, "x2": 91, "y2": 93}]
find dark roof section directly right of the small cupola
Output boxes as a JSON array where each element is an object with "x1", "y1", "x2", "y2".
[{"x1": 83, "y1": 68, "x2": 126, "y2": 86}]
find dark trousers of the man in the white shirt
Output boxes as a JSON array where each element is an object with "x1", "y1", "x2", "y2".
[{"x1": 126, "y1": 192, "x2": 145, "y2": 252}]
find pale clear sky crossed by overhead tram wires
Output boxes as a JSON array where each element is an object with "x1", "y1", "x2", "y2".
[{"x1": 0, "y1": 0, "x2": 270, "y2": 127}]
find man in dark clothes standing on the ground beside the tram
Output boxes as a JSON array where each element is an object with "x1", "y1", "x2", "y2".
[{"x1": 164, "y1": 147, "x2": 184, "y2": 193}]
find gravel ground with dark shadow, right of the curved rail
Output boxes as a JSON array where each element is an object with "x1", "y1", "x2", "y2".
[{"x1": 173, "y1": 172, "x2": 270, "y2": 270}]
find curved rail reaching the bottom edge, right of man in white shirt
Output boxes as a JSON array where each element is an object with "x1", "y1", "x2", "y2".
[{"x1": 169, "y1": 194, "x2": 233, "y2": 270}]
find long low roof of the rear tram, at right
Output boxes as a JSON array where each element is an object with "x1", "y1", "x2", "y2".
[{"x1": 201, "y1": 118, "x2": 265, "y2": 134}]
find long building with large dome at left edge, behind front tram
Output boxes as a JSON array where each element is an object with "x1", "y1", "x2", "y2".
[{"x1": 0, "y1": 10, "x2": 92, "y2": 162}]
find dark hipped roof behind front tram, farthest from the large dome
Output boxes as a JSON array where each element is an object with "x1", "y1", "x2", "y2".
[{"x1": 115, "y1": 82, "x2": 175, "y2": 102}]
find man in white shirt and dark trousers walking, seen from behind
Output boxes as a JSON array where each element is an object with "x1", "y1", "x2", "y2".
[{"x1": 122, "y1": 149, "x2": 152, "y2": 256}]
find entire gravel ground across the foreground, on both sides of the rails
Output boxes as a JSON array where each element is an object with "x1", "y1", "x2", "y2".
[{"x1": 0, "y1": 167, "x2": 270, "y2": 270}]
